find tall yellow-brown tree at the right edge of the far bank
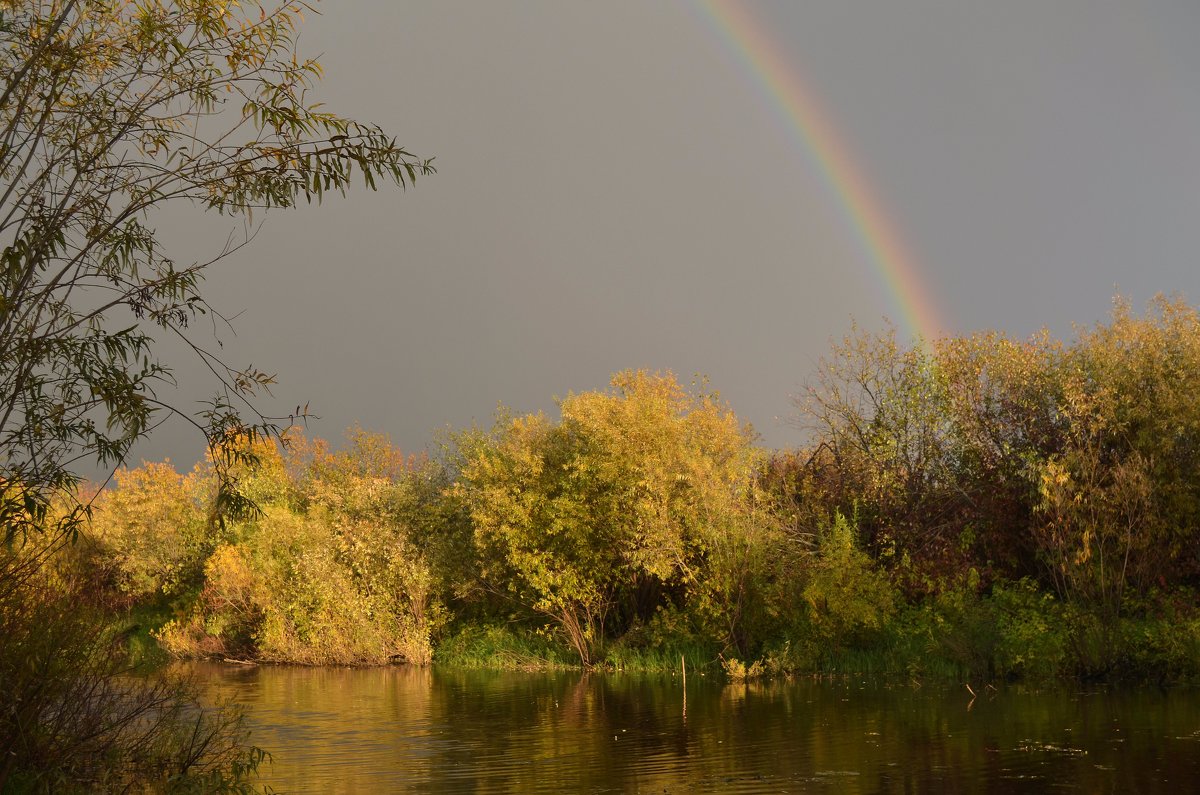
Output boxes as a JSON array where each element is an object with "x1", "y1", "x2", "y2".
[{"x1": 1034, "y1": 297, "x2": 1200, "y2": 615}]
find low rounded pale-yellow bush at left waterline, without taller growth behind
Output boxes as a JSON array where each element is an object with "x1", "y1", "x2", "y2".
[{"x1": 158, "y1": 506, "x2": 443, "y2": 665}]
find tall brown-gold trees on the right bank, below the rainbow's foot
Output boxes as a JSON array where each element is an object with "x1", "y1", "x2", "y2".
[{"x1": 796, "y1": 297, "x2": 1200, "y2": 616}]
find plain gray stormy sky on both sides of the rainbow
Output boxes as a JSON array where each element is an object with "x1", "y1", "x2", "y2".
[{"x1": 138, "y1": 0, "x2": 1200, "y2": 464}]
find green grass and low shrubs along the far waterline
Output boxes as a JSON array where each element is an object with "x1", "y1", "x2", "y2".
[{"x1": 417, "y1": 582, "x2": 1200, "y2": 685}]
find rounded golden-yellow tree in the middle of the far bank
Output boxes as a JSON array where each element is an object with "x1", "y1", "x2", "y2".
[{"x1": 460, "y1": 371, "x2": 756, "y2": 664}]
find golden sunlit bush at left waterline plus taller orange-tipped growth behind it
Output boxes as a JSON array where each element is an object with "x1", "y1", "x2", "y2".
[{"x1": 160, "y1": 434, "x2": 445, "y2": 664}]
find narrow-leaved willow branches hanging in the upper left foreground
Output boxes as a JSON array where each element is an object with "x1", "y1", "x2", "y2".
[{"x1": 0, "y1": 0, "x2": 432, "y2": 540}]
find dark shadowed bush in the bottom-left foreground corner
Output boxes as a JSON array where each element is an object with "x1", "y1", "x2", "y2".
[{"x1": 0, "y1": 545, "x2": 264, "y2": 793}]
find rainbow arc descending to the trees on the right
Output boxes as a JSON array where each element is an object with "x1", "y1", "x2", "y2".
[{"x1": 689, "y1": 0, "x2": 948, "y2": 340}]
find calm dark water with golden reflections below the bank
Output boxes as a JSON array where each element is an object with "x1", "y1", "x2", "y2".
[{"x1": 180, "y1": 664, "x2": 1200, "y2": 795}]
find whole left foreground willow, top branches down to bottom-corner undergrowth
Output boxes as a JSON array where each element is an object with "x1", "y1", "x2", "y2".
[{"x1": 0, "y1": 0, "x2": 433, "y2": 790}]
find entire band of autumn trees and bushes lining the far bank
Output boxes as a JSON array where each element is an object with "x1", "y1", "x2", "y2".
[{"x1": 75, "y1": 299, "x2": 1200, "y2": 677}]
